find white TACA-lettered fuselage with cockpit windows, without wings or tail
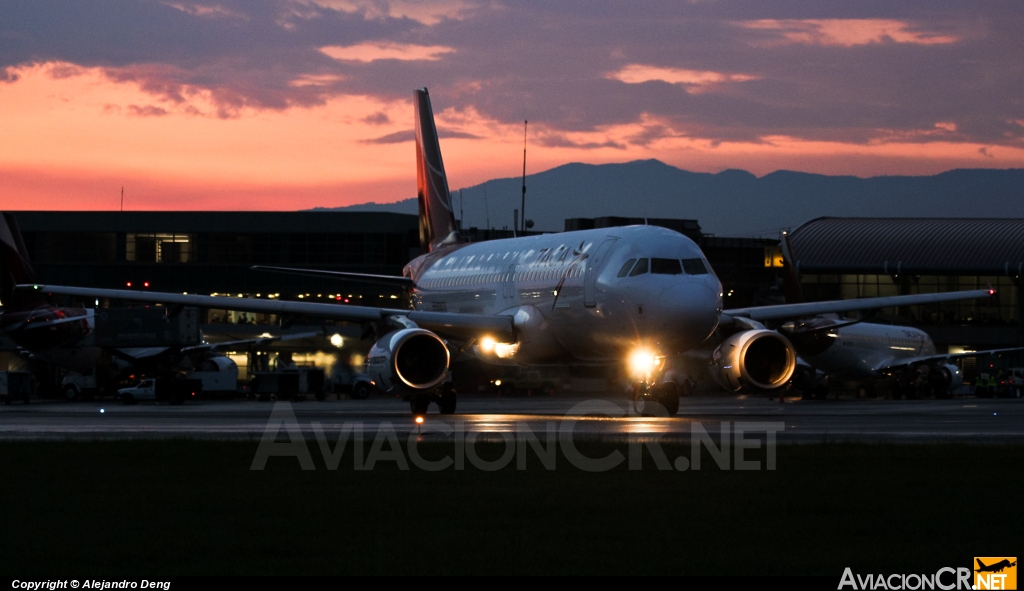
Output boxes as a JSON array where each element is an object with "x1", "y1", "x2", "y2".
[{"x1": 406, "y1": 226, "x2": 722, "y2": 365}]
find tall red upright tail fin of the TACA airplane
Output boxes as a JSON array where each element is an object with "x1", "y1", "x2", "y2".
[{"x1": 415, "y1": 88, "x2": 462, "y2": 251}]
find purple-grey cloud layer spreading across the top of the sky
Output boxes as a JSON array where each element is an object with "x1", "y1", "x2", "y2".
[{"x1": 0, "y1": 0, "x2": 1024, "y2": 146}]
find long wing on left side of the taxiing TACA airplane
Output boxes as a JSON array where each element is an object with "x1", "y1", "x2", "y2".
[{"x1": 17, "y1": 285, "x2": 516, "y2": 342}]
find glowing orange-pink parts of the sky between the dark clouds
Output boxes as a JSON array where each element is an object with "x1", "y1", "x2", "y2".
[{"x1": 0, "y1": 0, "x2": 1024, "y2": 210}]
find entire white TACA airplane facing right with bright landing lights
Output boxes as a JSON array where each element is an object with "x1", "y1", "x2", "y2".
[{"x1": 20, "y1": 88, "x2": 990, "y2": 416}]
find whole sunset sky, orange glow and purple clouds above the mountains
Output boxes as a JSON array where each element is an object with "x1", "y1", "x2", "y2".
[{"x1": 0, "y1": 0, "x2": 1024, "y2": 210}]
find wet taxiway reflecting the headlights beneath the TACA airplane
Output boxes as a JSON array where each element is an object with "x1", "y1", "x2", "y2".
[{"x1": 0, "y1": 395, "x2": 1024, "y2": 444}]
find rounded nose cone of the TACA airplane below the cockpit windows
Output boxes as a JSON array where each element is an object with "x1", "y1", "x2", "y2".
[{"x1": 651, "y1": 282, "x2": 721, "y2": 349}]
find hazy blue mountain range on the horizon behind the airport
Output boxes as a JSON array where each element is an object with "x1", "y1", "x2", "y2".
[{"x1": 317, "y1": 160, "x2": 1024, "y2": 237}]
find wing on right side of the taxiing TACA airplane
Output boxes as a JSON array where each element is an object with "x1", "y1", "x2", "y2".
[{"x1": 722, "y1": 289, "x2": 995, "y2": 324}]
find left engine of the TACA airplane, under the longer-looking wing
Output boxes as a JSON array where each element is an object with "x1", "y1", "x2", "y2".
[{"x1": 366, "y1": 329, "x2": 451, "y2": 392}]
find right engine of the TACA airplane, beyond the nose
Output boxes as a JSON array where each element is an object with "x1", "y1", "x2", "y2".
[{"x1": 711, "y1": 330, "x2": 797, "y2": 391}]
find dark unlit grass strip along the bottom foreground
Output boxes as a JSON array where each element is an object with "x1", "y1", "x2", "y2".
[{"x1": 0, "y1": 440, "x2": 1024, "y2": 579}]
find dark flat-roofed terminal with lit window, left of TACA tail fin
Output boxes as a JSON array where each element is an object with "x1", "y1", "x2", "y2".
[{"x1": 15, "y1": 211, "x2": 419, "y2": 324}]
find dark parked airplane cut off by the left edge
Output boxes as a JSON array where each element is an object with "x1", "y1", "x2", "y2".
[{"x1": 0, "y1": 212, "x2": 321, "y2": 399}]
